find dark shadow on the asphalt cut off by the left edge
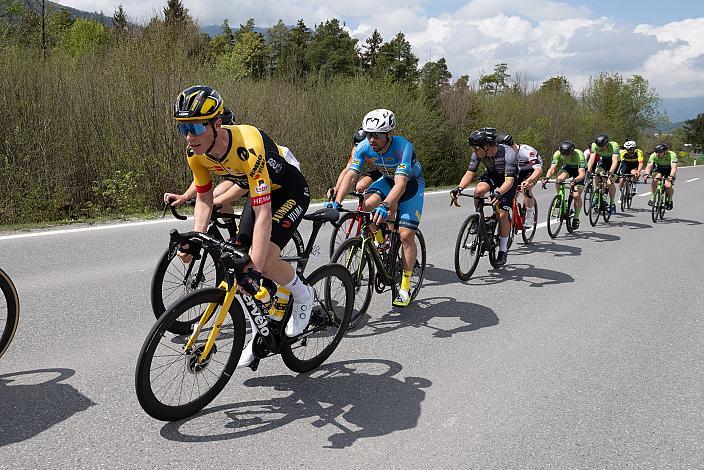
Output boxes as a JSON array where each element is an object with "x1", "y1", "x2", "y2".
[{"x1": 0, "y1": 368, "x2": 95, "y2": 447}]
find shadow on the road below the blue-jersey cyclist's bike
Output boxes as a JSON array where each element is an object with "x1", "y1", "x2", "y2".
[{"x1": 346, "y1": 297, "x2": 499, "y2": 338}]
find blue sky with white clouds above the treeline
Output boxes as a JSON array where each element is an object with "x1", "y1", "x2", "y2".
[{"x1": 59, "y1": 0, "x2": 704, "y2": 98}]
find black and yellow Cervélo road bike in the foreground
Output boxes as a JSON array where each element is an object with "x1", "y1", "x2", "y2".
[{"x1": 135, "y1": 211, "x2": 354, "y2": 421}]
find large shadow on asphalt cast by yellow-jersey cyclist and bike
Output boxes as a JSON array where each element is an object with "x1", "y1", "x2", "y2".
[{"x1": 161, "y1": 359, "x2": 432, "y2": 449}]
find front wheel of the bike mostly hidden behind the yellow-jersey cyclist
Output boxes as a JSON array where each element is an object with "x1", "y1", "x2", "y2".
[{"x1": 151, "y1": 249, "x2": 225, "y2": 335}]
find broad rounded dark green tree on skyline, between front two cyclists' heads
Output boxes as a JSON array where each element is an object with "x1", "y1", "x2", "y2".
[{"x1": 306, "y1": 19, "x2": 359, "y2": 78}]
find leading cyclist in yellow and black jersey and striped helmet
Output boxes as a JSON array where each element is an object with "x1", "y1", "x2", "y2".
[{"x1": 174, "y1": 85, "x2": 313, "y2": 366}]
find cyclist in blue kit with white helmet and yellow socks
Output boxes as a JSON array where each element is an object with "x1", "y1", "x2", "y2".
[{"x1": 325, "y1": 109, "x2": 425, "y2": 307}]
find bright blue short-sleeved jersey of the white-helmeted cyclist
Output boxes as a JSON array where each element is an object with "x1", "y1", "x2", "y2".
[{"x1": 349, "y1": 135, "x2": 423, "y2": 180}]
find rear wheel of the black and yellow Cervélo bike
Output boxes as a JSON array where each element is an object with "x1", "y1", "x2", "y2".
[{"x1": 281, "y1": 264, "x2": 354, "y2": 372}]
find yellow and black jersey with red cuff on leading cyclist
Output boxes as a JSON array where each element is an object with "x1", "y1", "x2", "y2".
[{"x1": 188, "y1": 125, "x2": 302, "y2": 206}]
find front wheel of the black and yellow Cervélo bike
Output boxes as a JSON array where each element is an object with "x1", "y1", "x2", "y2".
[{"x1": 135, "y1": 288, "x2": 246, "y2": 421}]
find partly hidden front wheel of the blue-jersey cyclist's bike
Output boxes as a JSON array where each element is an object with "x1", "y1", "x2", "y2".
[{"x1": 330, "y1": 237, "x2": 375, "y2": 329}]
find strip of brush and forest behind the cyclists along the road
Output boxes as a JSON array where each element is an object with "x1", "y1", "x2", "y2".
[{"x1": 0, "y1": 0, "x2": 704, "y2": 224}]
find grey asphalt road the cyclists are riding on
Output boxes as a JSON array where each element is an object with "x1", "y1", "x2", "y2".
[{"x1": 0, "y1": 168, "x2": 704, "y2": 469}]
